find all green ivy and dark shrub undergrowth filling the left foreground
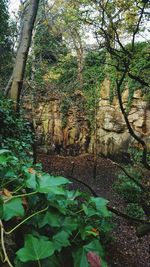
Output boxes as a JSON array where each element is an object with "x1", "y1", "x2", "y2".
[{"x1": 0, "y1": 97, "x2": 112, "y2": 267}]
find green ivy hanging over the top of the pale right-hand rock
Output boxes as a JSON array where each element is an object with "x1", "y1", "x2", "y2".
[{"x1": 106, "y1": 42, "x2": 150, "y2": 108}]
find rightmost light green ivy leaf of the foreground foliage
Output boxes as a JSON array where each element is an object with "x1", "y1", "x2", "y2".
[{"x1": 91, "y1": 197, "x2": 111, "y2": 217}]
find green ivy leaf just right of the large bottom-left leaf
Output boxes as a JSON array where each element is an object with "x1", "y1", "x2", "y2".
[{"x1": 53, "y1": 231, "x2": 70, "y2": 252}]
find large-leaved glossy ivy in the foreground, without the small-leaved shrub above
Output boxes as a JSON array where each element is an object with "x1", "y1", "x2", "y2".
[{"x1": 0, "y1": 149, "x2": 111, "y2": 267}]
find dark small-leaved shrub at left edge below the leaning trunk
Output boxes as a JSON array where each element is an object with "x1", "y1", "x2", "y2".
[{"x1": 0, "y1": 95, "x2": 33, "y2": 160}]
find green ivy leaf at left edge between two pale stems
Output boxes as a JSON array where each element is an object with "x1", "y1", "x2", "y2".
[{"x1": 3, "y1": 198, "x2": 24, "y2": 221}]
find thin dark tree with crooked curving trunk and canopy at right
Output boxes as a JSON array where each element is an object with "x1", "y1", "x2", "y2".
[{"x1": 82, "y1": 0, "x2": 150, "y2": 169}]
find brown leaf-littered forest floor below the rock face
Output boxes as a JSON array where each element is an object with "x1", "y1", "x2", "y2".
[{"x1": 38, "y1": 155, "x2": 150, "y2": 267}]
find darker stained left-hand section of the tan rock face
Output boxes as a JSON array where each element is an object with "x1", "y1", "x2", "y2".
[{"x1": 23, "y1": 95, "x2": 91, "y2": 155}]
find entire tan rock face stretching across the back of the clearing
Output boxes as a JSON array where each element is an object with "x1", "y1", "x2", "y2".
[{"x1": 24, "y1": 79, "x2": 150, "y2": 156}]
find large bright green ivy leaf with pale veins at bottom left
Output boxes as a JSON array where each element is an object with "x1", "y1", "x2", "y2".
[{"x1": 16, "y1": 235, "x2": 54, "y2": 262}]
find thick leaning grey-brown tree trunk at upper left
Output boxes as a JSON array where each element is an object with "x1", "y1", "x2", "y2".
[{"x1": 10, "y1": 0, "x2": 39, "y2": 110}]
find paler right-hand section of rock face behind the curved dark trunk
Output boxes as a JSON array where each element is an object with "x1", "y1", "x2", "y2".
[{"x1": 97, "y1": 80, "x2": 150, "y2": 156}]
